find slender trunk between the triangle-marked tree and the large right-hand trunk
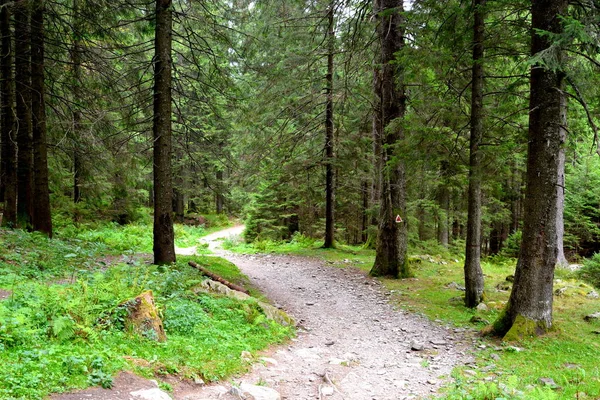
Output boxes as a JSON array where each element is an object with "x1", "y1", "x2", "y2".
[{"x1": 464, "y1": 0, "x2": 485, "y2": 308}]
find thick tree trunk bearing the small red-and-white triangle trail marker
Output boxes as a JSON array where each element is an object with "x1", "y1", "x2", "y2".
[{"x1": 370, "y1": 0, "x2": 410, "y2": 277}]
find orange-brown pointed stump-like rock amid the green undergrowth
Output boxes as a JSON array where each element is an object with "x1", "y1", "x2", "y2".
[{"x1": 116, "y1": 290, "x2": 167, "y2": 342}]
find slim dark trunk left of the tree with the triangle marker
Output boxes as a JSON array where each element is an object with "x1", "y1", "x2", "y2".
[{"x1": 323, "y1": 1, "x2": 335, "y2": 249}]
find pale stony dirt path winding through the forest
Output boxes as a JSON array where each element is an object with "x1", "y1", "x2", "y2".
[{"x1": 51, "y1": 227, "x2": 478, "y2": 400}]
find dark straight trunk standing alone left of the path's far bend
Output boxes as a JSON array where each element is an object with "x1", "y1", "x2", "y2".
[{"x1": 152, "y1": 0, "x2": 175, "y2": 264}]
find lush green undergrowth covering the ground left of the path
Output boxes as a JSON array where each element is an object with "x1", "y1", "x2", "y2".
[{"x1": 0, "y1": 229, "x2": 292, "y2": 399}]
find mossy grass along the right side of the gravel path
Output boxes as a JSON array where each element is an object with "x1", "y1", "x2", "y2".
[{"x1": 226, "y1": 238, "x2": 600, "y2": 400}]
